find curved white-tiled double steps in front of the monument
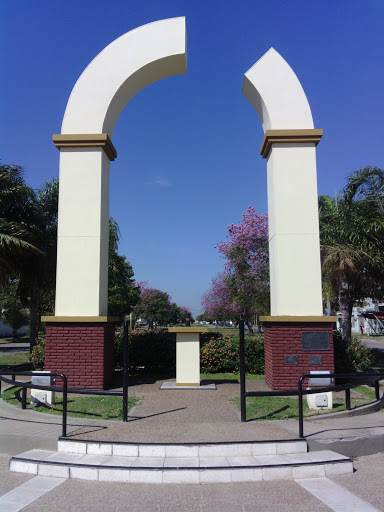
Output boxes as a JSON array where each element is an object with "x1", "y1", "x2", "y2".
[{"x1": 10, "y1": 441, "x2": 353, "y2": 484}]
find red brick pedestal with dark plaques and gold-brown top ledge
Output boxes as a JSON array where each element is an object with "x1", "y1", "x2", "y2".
[{"x1": 260, "y1": 316, "x2": 336, "y2": 390}]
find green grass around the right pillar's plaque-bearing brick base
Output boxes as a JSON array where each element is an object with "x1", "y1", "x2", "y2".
[{"x1": 232, "y1": 386, "x2": 375, "y2": 421}]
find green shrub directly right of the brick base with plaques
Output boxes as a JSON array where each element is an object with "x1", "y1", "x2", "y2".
[{"x1": 333, "y1": 331, "x2": 373, "y2": 373}]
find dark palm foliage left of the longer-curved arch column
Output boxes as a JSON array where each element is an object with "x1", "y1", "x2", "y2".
[{"x1": 0, "y1": 165, "x2": 59, "y2": 348}]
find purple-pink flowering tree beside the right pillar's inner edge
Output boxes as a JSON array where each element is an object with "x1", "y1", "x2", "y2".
[{"x1": 202, "y1": 206, "x2": 269, "y2": 333}]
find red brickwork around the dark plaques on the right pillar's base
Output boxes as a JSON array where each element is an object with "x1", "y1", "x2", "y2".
[{"x1": 264, "y1": 322, "x2": 335, "y2": 390}]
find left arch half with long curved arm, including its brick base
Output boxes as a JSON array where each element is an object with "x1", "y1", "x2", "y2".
[{"x1": 42, "y1": 18, "x2": 186, "y2": 388}]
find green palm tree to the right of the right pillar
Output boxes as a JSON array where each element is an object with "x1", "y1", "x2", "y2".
[{"x1": 319, "y1": 167, "x2": 384, "y2": 339}]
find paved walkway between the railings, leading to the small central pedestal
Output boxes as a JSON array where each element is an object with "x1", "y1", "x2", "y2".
[{"x1": 67, "y1": 381, "x2": 297, "y2": 443}]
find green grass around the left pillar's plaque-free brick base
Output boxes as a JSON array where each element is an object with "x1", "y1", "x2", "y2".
[{"x1": 1, "y1": 387, "x2": 140, "y2": 420}]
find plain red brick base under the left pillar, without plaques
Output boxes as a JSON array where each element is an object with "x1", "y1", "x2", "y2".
[{"x1": 44, "y1": 322, "x2": 114, "y2": 389}]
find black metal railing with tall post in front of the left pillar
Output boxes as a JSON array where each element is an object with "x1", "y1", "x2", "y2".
[{"x1": 0, "y1": 321, "x2": 128, "y2": 437}]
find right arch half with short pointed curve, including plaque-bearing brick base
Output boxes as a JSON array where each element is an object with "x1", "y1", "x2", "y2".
[{"x1": 242, "y1": 48, "x2": 334, "y2": 389}]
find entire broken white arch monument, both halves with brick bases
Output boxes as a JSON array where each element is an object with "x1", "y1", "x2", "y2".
[{"x1": 43, "y1": 25, "x2": 334, "y2": 389}]
